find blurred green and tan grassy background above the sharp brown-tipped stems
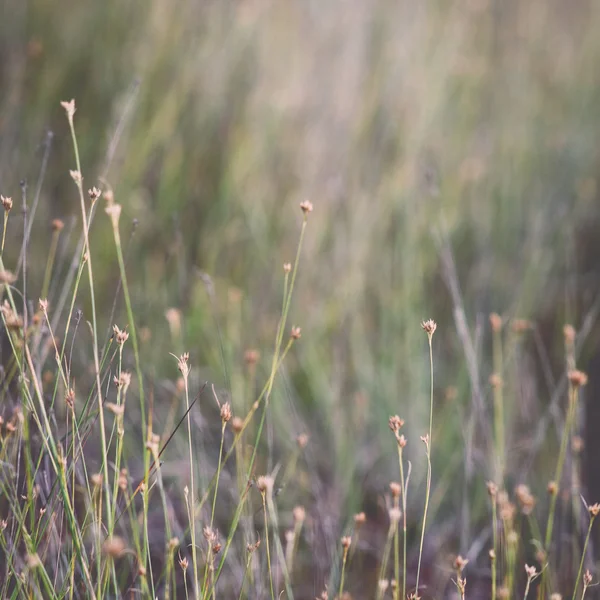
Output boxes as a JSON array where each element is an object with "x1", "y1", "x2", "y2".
[{"x1": 0, "y1": 0, "x2": 600, "y2": 597}]
